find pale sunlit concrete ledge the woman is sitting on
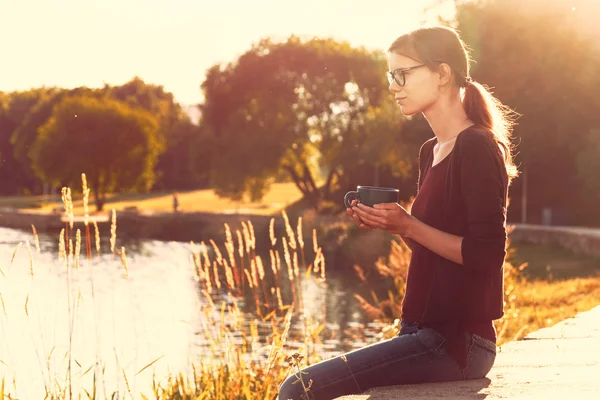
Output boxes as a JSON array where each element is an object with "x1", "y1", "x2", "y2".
[{"x1": 338, "y1": 306, "x2": 600, "y2": 400}]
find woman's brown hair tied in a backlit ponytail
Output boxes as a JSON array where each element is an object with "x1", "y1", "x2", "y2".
[{"x1": 388, "y1": 26, "x2": 518, "y2": 179}]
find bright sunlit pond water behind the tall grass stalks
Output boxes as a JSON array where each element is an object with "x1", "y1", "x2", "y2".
[{"x1": 0, "y1": 228, "x2": 380, "y2": 399}]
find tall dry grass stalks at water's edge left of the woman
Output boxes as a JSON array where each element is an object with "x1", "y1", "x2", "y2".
[{"x1": 0, "y1": 176, "x2": 326, "y2": 400}]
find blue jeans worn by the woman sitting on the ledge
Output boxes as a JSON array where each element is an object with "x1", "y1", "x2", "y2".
[{"x1": 279, "y1": 328, "x2": 496, "y2": 400}]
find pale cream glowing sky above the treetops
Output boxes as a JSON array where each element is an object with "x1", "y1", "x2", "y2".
[{"x1": 0, "y1": 0, "x2": 453, "y2": 105}]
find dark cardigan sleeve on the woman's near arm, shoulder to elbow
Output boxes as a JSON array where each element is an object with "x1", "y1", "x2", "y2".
[{"x1": 460, "y1": 132, "x2": 508, "y2": 274}]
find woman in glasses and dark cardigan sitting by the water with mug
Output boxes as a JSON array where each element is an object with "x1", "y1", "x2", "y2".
[{"x1": 279, "y1": 27, "x2": 517, "y2": 400}]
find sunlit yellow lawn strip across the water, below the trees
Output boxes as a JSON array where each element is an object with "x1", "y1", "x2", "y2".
[{"x1": 0, "y1": 183, "x2": 310, "y2": 215}]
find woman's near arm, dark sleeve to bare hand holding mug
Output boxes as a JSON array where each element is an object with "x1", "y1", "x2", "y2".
[{"x1": 353, "y1": 135, "x2": 508, "y2": 273}]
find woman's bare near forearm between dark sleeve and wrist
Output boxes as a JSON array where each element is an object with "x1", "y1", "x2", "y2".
[{"x1": 405, "y1": 217, "x2": 463, "y2": 265}]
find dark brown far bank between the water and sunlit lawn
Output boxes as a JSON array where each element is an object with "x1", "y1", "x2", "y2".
[{"x1": 0, "y1": 209, "x2": 392, "y2": 276}]
